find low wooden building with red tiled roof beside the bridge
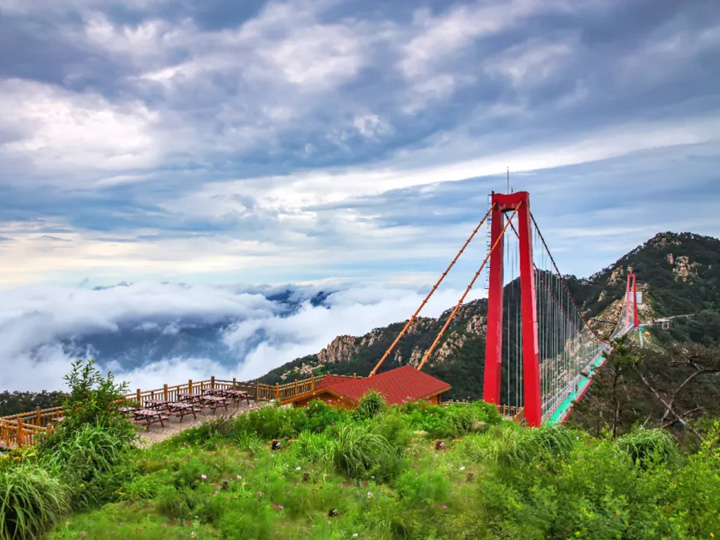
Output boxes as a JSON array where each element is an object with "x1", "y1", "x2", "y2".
[{"x1": 285, "y1": 365, "x2": 451, "y2": 409}]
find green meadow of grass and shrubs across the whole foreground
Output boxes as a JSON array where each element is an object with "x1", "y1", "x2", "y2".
[{"x1": 0, "y1": 386, "x2": 720, "y2": 540}]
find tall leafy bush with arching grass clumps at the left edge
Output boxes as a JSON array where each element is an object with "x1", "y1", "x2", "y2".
[{"x1": 0, "y1": 361, "x2": 137, "y2": 540}]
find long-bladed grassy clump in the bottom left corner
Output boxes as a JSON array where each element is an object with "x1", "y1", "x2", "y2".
[{"x1": 0, "y1": 463, "x2": 68, "y2": 540}]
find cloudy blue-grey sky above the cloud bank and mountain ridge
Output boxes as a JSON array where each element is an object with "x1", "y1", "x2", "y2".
[{"x1": 0, "y1": 0, "x2": 720, "y2": 388}]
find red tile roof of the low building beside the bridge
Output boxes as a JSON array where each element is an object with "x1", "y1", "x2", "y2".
[{"x1": 318, "y1": 365, "x2": 450, "y2": 405}]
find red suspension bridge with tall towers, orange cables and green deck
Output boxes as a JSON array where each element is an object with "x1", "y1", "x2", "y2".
[{"x1": 370, "y1": 191, "x2": 639, "y2": 426}]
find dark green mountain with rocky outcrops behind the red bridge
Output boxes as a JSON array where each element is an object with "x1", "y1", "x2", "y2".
[{"x1": 261, "y1": 232, "x2": 720, "y2": 398}]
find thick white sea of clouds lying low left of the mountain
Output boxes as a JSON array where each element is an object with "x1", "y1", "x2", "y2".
[{"x1": 0, "y1": 282, "x2": 484, "y2": 390}]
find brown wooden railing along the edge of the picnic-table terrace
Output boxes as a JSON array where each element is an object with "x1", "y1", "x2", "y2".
[{"x1": 0, "y1": 375, "x2": 355, "y2": 448}]
